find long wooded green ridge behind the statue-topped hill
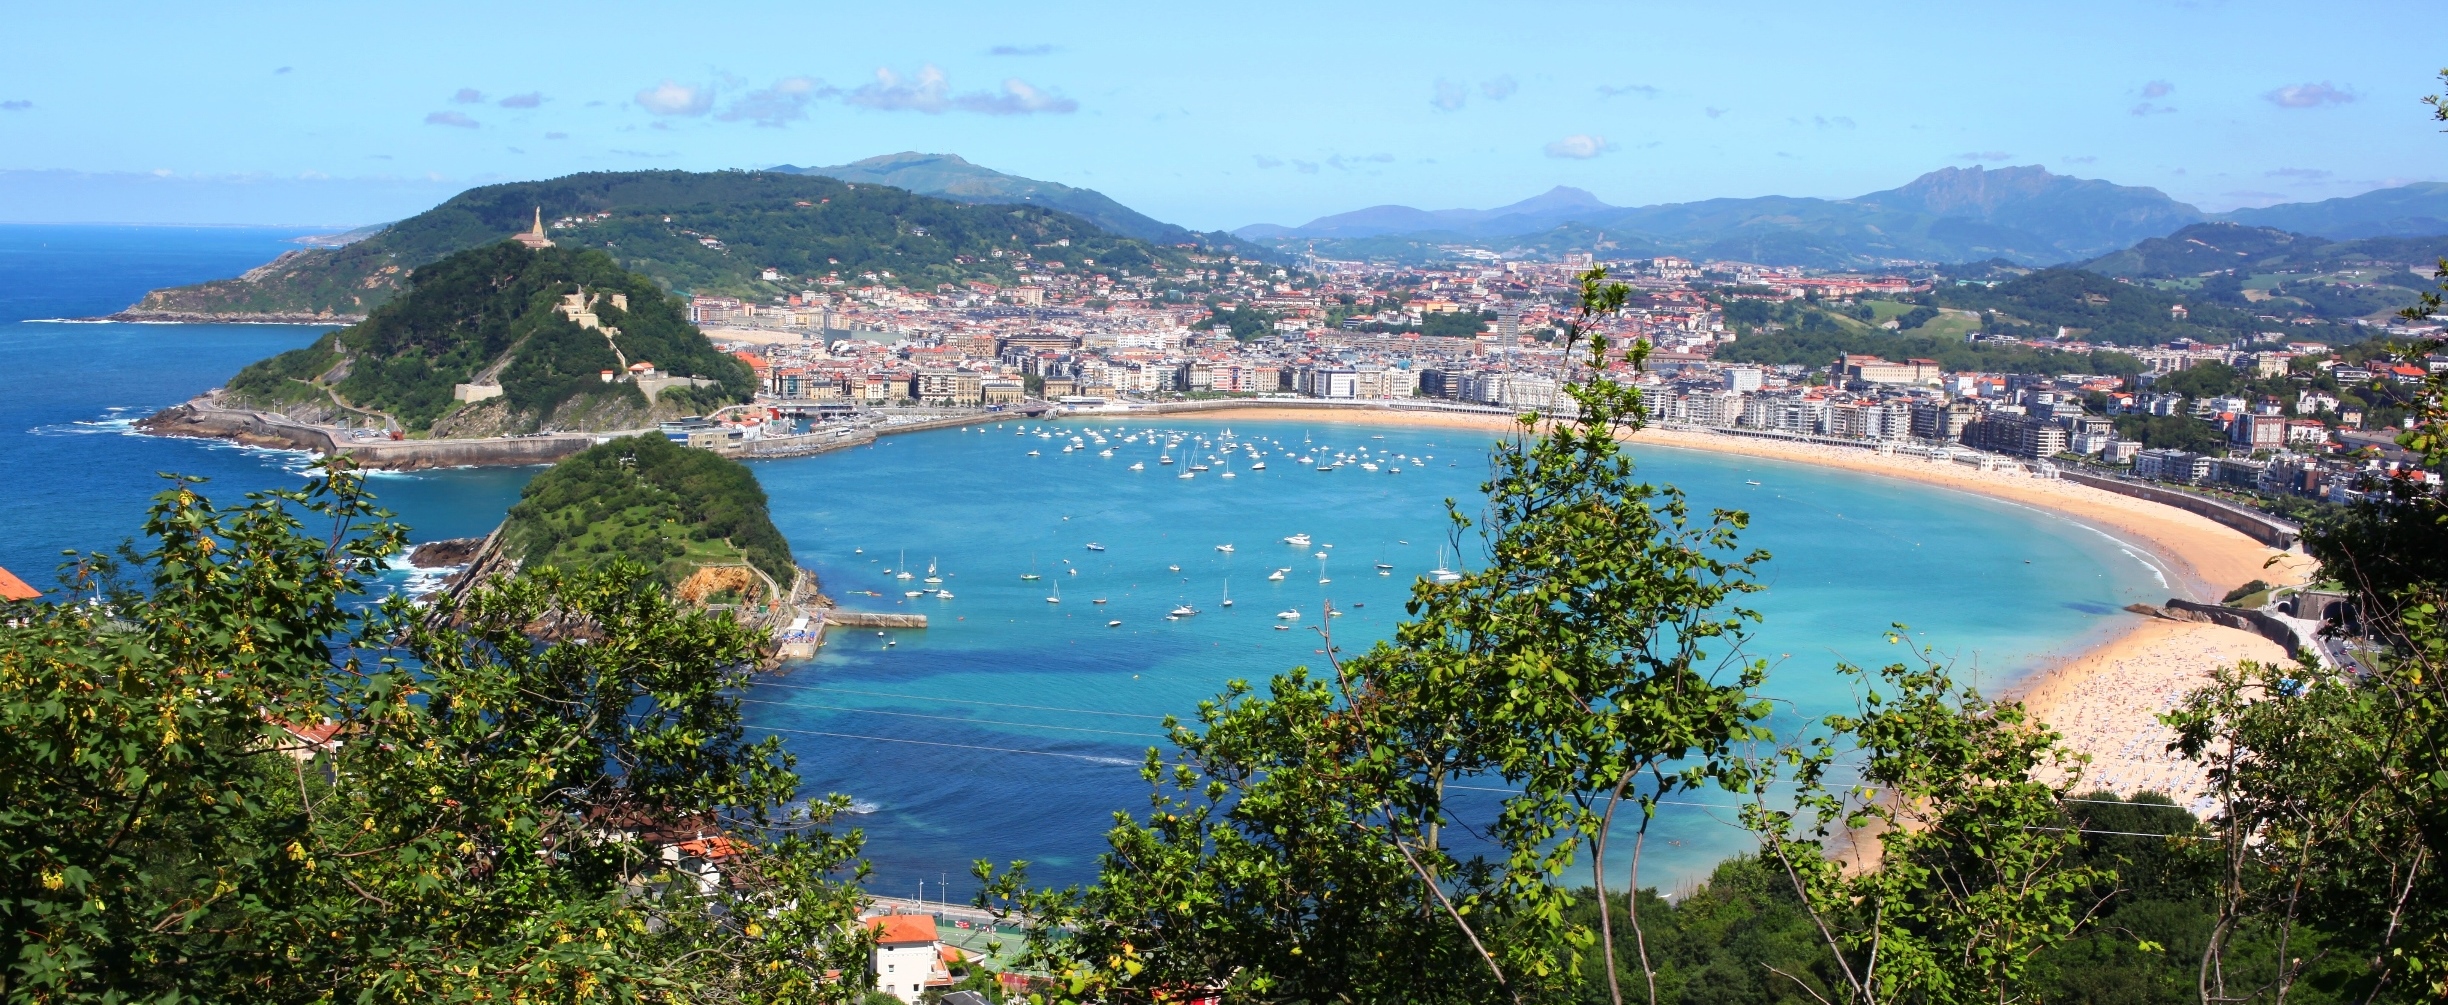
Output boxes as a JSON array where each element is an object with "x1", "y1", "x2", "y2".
[{"x1": 127, "y1": 171, "x2": 1185, "y2": 318}]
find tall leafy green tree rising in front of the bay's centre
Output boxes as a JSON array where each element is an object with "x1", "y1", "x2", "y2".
[{"x1": 979, "y1": 269, "x2": 1767, "y2": 1003}]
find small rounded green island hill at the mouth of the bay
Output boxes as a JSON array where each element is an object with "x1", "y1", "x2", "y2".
[{"x1": 502, "y1": 435, "x2": 793, "y2": 589}]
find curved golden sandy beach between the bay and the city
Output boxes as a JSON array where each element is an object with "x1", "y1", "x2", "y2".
[{"x1": 1180, "y1": 406, "x2": 2311, "y2": 802}]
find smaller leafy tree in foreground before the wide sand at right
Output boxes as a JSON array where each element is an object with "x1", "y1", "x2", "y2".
[{"x1": 1743, "y1": 655, "x2": 2115, "y2": 1005}]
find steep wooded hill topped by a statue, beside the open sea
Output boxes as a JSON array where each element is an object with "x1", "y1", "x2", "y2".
[{"x1": 223, "y1": 242, "x2": 756, "y2": 435}]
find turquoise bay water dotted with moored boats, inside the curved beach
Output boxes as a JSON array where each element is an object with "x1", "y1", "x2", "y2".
[{"x1": 752, "y1": 421, "x2": 2166, "y2": 895}]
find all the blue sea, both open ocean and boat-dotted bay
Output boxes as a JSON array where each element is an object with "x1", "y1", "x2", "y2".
[{"x1": 0, "y1": 225, "x2": 2169, "y2": 902}]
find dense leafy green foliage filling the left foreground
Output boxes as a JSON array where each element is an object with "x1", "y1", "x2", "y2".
[{"x1": 0, "y1": 472, "x2": 864, "y2": 1003}]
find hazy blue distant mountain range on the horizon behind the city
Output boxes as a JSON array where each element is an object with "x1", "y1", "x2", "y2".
[{"x1": 1234, "y1": 166, "x2": 2448, "y2": 267}]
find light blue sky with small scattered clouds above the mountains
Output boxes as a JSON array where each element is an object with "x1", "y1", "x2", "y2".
[{"x1": 0, "y1": 0, "x2": 2448, "y2": 230}]
